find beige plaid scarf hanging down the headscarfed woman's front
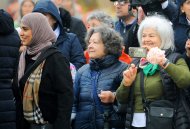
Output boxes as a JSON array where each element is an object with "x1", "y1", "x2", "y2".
[{"x1": 23, "y1": 61, "x2": 45, "y2": 124}]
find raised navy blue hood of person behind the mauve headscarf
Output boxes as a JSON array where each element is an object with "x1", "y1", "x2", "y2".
[{"x1": 33, "y1": 0, "x2": 63, "y2": 28}]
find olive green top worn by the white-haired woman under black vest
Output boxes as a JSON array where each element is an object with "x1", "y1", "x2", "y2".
[{"x1": 116, "y1": 58, "x2": 190, "y2": 113}]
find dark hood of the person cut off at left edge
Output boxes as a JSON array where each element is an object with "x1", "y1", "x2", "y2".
[{"x1": 0, "y1": 9, "x2": 15, "y2": 35}]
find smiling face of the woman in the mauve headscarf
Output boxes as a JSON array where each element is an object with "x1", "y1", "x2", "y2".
[{"x1": 20, "y1": 24, "x2": 32, "y2": 46}]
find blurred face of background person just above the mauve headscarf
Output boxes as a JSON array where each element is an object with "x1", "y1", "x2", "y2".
[{"x1": 21, "y1": 1, "x2": 34, "y2": 16}]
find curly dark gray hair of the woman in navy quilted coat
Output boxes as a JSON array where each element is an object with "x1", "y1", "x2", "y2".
[{"x1": 85, "y1": 26, "x2": 123, "y2": 57}]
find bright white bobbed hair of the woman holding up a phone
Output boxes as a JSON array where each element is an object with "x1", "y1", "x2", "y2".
[{"x1": 138, "y1": 15, "x2": 175, "y2": 51}]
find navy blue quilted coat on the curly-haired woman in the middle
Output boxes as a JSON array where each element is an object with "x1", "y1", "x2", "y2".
[{"x1": 73, "y1": 55, "x2": 127, "y2": 129}]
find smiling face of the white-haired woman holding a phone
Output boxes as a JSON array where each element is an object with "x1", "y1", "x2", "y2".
[{"x1": 141, "y1": 28, "x2": 162, "y2": 48}]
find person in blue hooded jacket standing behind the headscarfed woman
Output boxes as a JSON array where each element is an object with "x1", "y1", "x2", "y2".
[{"x1": 33, "y1": 0, "x2": 85, "y2": 70}]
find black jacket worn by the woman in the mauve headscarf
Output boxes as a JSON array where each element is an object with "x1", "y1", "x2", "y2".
[{"x1": 20, "y1": 48, "x2": 73, "y2": 129}]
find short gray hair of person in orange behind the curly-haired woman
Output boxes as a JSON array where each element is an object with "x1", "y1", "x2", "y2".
[{"x1": 87, "y1": 10, "x2": 114, "y2": 28}]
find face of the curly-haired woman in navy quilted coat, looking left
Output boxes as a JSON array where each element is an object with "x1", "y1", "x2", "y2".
[{"x1": 88, "y1": 33, "x2": 106, "y2": 59}]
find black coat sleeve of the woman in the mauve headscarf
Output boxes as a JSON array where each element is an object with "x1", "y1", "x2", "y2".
[{"x1": 52, "y1": 54, "x2": 73, "y2": 129}]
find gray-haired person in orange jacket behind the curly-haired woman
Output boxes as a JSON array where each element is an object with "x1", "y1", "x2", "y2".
[{"x1": 84, "y1": 10, "x2": 132, "y2": 64}]
